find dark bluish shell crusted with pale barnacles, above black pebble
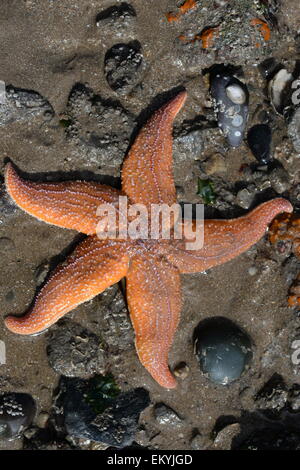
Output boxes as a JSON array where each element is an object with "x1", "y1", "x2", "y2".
[{"x1": 211, "y1": 73, "x2": 249, "y2": 147}]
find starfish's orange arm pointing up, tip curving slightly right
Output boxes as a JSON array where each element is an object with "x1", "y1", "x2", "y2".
[{"x1": 122, "y1": 91, "x2": 186, "y2": 208}]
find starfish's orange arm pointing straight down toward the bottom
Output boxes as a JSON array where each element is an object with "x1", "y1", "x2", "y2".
[{"x1": 126, "y1": 255, "x2": 181, "y2": 388}]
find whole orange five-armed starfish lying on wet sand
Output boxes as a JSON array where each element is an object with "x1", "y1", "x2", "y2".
[{"x1": 5, "y1": 91, "x2": 292, "y2": 388}]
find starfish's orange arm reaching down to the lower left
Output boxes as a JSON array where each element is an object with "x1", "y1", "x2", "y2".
[{"x1": 5, "y1": 236, "x2": 129, "y2": 335}]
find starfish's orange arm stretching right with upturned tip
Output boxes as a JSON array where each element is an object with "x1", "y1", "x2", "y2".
[{"x1": 166, "y1": 198, "x2": 293, "y2": 273}]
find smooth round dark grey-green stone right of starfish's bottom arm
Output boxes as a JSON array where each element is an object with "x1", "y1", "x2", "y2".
[{"x1": 194, "y1": 317, "x2": 252, "y2": 385}]
